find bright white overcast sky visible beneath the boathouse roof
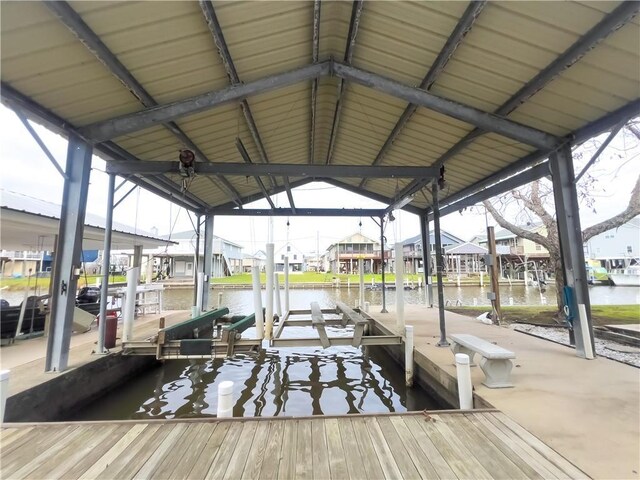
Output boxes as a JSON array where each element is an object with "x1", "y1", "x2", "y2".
[{"x1": 0, "y1": 105, "x2": 640, "y2": 253}]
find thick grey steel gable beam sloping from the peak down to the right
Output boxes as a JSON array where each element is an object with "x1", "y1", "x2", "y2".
[{"x1": 333, "y1": 62, "x2": 561, "y2": 150}]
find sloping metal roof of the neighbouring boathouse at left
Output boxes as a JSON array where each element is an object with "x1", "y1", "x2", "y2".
[{"x1": 0, "y1": 190, "x2": 176, "y2": 251}]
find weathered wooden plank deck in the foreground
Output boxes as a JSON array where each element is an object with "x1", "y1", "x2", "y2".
[{"x1": 0, "y1": 411, "x2": 586, "y2": 480}]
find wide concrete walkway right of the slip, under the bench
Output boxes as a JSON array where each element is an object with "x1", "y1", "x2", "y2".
[{"x1": 369, "y1": 305, "x2": 640, "y2": 479}]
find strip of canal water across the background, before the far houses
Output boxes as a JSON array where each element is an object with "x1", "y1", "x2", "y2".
[{"x1": 164, "y1": 285, "x2": 640, "y2": 314}]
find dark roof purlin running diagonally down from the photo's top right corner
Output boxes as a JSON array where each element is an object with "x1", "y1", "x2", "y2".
[{"x1": 398, "y1": 1, "x2": 640, "y2": 199}]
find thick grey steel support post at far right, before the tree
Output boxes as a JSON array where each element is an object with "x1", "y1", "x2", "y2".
[{"x1": 550, "y1": 145, "x2": 595, "y2": 358}]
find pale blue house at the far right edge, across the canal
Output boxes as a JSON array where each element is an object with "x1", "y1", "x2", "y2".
[{"x1": 585, "y1": 216, "x2": 640, "y2": 270}]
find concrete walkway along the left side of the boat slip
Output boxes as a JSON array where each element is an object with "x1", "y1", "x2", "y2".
[{"x1": 0, "y1": 311, "x2": 189, "y2": 396}]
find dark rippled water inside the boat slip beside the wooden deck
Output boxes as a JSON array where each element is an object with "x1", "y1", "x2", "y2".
[{"x1": 74, "y1": 338, "x2": 439, "y2": 420}]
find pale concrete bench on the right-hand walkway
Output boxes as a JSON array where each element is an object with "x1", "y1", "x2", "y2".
[{"x1": 449, "y1": 334, "x2": 516, "y2": 388}]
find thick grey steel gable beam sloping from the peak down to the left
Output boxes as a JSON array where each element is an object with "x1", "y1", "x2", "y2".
[{"x1": 80, "y1": 61, "x2": 331, "y2": 142}]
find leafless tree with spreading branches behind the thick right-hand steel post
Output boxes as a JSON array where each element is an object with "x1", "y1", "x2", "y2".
[{"x1": 483, "y1": 121, "x2": 640, "y2": 312}]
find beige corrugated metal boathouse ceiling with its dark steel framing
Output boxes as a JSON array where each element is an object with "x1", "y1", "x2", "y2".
[{"x1": 0, "y1": 1, "x2": 640, "y2": 213}]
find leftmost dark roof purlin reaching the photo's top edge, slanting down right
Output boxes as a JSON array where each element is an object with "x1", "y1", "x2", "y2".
[{"x1": 44, "y1": 1, "x2": 240, "y2": 205}]
